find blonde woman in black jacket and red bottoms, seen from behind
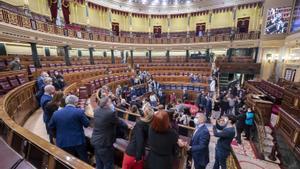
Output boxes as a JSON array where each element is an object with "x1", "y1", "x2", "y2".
[{"x1": 122, "y1": 106, "x2": 154, "y2": 169}]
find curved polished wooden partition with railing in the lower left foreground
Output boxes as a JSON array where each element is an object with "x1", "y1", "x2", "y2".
[{"x1": 0, "y1": 81, "x2": 92, "y2": 169}]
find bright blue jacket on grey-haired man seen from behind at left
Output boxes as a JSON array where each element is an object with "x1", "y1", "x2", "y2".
[{"x1": 48, "y1": 105, "x2": 89, "y2": 148}]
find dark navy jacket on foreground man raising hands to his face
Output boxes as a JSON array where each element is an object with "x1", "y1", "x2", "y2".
[{"x1": 213, "y1": 126, "x2": 235, "y2": 153}]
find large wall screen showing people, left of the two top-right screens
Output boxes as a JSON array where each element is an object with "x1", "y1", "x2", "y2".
[{"x1": 265, "y1": 7, "x2": 291, "y2": 34}]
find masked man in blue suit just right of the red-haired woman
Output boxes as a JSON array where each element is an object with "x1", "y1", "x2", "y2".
[{"x1": 190, "y1": 113, "x2": 210, "y2": 169}]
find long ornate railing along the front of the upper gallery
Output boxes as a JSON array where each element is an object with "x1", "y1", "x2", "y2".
[{"x1": 0, "y1": 9, "x2": 260, "y2": 44}]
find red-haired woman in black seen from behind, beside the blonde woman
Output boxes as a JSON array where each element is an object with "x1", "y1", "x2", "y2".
[{"x1": 147, "y1": 111, "x2": 180, "y2": 169}]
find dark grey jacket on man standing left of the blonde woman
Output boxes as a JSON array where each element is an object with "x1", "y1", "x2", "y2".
[{"x1": 91, "y1": 107, "x2": 119, "y2": 147}]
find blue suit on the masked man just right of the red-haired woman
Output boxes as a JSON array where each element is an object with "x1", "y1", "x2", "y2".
[{"x1": 190, "y1": 125, "x2": 210, "y2": 166}]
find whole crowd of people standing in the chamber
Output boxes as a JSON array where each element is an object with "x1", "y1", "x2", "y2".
[{"x1": 37, "y1": 67, "x2": 254, "y2": 169}]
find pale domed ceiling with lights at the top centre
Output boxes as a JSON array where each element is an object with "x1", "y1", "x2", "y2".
[{"x1": 87, "y1": 0, "x2": 263, "y2": 14}]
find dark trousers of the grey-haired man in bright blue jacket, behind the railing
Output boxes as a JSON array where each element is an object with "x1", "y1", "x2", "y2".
[{"x1": 62, "y1": 144, "x2": 88, "y2": 163}]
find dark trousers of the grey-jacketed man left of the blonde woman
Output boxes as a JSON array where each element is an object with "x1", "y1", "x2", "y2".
[{"x1": 94, "y1": 145, "x2": 114, "y2": 169}]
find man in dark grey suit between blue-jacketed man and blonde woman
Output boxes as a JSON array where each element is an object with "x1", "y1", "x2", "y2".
[{"x1": 91, "y1": 97, "x2": 119, "y2": 169}]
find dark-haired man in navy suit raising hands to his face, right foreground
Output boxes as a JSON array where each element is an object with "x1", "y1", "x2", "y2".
[{"x1": 213, "y1": 115, "x2": 236, "y2": 169}]
